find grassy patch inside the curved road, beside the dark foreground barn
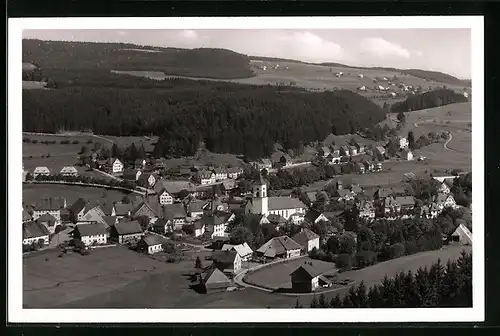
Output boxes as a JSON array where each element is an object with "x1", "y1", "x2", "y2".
[{"x1": 246, "y1": 257, "x2": 336, "y2": 289}]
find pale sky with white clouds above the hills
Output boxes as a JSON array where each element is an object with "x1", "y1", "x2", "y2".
[{"x1": 23, "y1": 29, "x2": 471, "y2": 79}]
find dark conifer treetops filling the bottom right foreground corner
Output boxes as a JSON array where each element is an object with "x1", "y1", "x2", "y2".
[{"x1": 295, "y1": 251, "x2": 472, "y2": 308}]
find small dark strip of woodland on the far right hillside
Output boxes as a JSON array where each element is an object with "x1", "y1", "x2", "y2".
[{"x1": 391, "y1": 89, "x2": 469, "y2": 113}]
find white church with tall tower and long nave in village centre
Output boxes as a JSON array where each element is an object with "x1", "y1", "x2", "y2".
[{"x1": 245, "y1": 175, "x2": 306, "y2": 220}]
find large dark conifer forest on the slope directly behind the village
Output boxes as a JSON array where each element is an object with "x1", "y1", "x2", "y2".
[{"x1": 23, "y1": 79, "x2": 385, "y2": 159}]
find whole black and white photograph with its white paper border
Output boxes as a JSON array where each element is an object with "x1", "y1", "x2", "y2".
[{"x1": 8, "y1": 16, "x2": 484, "y2": 322}]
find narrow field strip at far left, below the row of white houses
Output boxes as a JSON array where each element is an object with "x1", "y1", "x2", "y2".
[{"x1": 23, "y1": 184, "x2": 127, "y2": 206}]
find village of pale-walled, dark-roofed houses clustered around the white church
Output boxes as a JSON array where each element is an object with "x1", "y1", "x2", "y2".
[{"x1": 22, "y1": 129, "x2": 472, "y2": 293}]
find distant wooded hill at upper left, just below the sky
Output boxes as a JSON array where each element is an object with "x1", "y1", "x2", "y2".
[{"x1": 23, "y1": 40, "x2": 253, "y2": 80}]
